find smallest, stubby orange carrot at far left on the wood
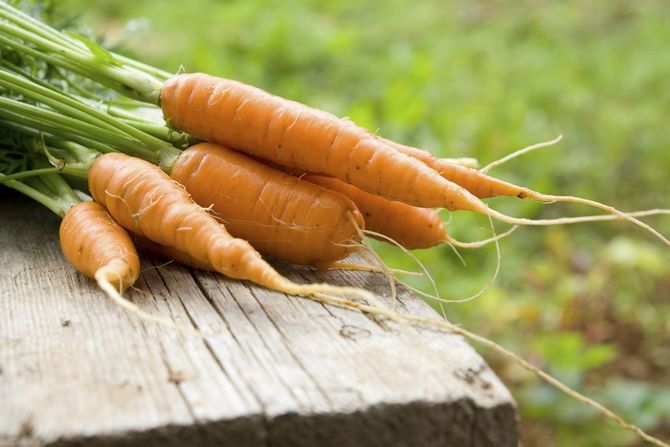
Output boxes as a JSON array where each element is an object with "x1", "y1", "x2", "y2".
[{"x1": 59, "y1": 202, "x2": 140, "y2": 291}]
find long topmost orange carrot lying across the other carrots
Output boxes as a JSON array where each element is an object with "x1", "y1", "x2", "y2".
[{"x1": 160, "y1": 73, "x2": 670, "y2": 250}]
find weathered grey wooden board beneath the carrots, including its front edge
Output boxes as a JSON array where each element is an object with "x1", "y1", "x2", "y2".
[{"x1": 0, "y1": 195, "x2": 517, "y2": 447}]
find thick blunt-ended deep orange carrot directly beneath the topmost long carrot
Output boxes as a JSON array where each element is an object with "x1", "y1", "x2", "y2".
[{"x1": 170, "y1": 143, "x2": 365, "y2": 264}]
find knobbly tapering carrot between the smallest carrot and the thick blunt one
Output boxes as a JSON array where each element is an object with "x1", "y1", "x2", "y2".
[{"x1": 88, "y1": 153, "x2": 374, "y2": 300}]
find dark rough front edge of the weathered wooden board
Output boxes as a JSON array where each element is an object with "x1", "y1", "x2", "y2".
[{"x1": 9, "y1": 398, "x2": 519, "y2": 447}]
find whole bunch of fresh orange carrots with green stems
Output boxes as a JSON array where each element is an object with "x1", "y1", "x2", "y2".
[{"x1": 0, "y1": 2, "x2": 670, "y2": 444}]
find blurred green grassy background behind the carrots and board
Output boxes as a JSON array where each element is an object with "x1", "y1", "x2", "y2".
[{"x1": 56, "y1": 0, "x2": 670, "y2": 446}]
